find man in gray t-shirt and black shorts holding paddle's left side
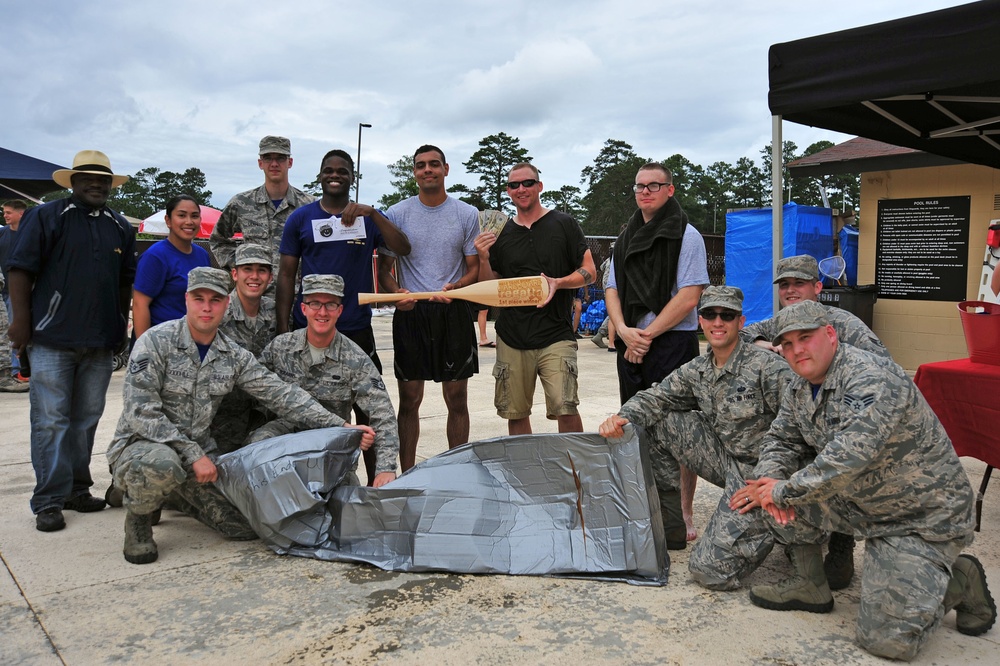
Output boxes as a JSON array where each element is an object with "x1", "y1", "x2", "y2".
[{"x1": 378, "y1": 145, "x2": 479, "y2": 472}]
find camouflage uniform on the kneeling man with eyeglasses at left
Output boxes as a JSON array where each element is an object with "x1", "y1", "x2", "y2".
[{"x1": 251, "y1": 328, "x2": 399, "y2": 474}]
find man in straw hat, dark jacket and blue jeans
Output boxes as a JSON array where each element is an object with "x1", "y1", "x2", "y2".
[{"x1": 9, "y1": 150, "x2": 136, "y2": 532}]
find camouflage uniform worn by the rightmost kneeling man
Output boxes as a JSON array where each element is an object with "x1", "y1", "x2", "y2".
[{"x1": 754, "y1": 345, "x2": 973, "y2": 659}]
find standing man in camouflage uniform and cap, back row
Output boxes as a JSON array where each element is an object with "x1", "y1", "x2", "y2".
[{"x1": 209, "y1": 136, "x2": 314, "y2": 286}]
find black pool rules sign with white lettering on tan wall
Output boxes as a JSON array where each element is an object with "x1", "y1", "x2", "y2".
[{"x1": 875, "y1": 196, "x2": 971, "y2": 301}]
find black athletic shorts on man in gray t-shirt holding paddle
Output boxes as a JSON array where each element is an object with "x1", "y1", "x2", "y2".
[{"x1": 392, "y1": 300, "x2": 479, "y2": 382}]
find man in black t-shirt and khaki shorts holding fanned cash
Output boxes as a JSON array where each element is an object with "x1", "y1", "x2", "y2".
[{"x1": 476, "y1": 163, "x2": 597, "y2": 435}]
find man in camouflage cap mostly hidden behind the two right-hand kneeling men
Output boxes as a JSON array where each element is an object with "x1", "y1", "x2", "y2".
[{"x1": 741, "y1": 254, "x2": 893, "y2": 590}]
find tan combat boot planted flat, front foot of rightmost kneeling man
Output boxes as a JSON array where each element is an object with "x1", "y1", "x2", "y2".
[{"x1": 750, "y1": 544, "x2": 833, "y2": 613}]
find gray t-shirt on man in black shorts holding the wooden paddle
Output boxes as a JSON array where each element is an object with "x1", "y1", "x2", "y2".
[{"x1": 382, "y1": 197, "x2": 479, "y2": 291}]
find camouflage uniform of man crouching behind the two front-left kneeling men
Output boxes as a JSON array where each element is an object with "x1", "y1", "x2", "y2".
[{"x1": 212, "y1": 289, "x2": 275, "y2": 453}]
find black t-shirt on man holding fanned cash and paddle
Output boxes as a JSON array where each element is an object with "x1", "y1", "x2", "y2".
[{"x1": 490, "y1": 211, "x2": 587, "y2": 349}]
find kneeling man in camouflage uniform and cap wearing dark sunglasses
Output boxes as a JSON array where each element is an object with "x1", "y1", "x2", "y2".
[{"x1": 599, "y1": 286, "x2": 792, "y2": 590}]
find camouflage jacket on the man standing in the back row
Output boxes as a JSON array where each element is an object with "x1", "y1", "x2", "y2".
[{"x1": 209, "y1": 185, "x2": 316, "y2": 274}]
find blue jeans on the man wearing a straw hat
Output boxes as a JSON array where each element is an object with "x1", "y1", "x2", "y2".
[{"x1": 28, "y1": 344, "x2": 114, "y2": 513}]
